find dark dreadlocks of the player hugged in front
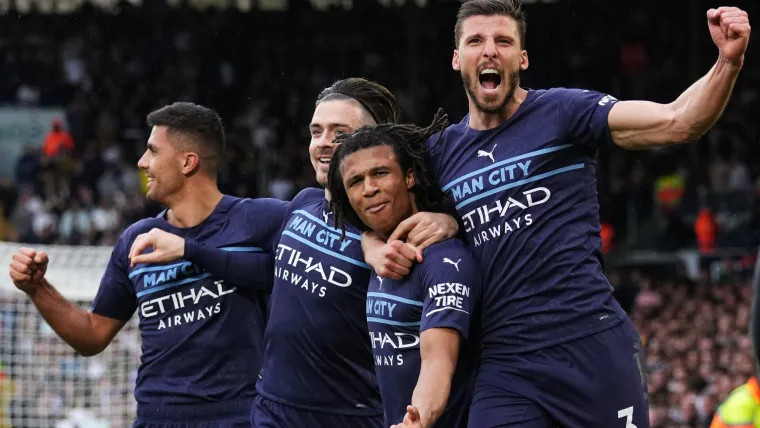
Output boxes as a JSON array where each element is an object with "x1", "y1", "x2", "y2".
[{"x1": 327, "y1": 109, "x2": 449, "y2": 239}]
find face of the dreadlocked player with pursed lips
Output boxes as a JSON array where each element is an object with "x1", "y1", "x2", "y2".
[{"x1": 340, "y1": 146, "x2": 414, "y2": 236}]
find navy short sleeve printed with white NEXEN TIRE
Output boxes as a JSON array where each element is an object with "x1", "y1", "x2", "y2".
[{"x1": 419, "y1": 239, "x2": 481, "y2": 339}]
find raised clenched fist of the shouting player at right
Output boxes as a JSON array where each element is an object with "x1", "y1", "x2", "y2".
[{"x1": 707, "y1": 7, "x2": 752, "y2": 66}]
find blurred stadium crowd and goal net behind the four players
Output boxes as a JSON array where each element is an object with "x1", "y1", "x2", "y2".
[{"x1": 0, "y1": 0, "x2": 760, "y2": 428}]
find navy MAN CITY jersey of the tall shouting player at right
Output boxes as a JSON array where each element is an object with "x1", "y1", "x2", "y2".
[{"x1": 428, "y1": 88, "x2": 625, "y2": 359}]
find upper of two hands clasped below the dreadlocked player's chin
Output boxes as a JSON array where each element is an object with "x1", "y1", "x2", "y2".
[{"x1": 388, "y1": 213, "x2": 459, "y2": 250}]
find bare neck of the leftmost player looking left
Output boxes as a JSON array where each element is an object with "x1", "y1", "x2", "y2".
[{"x1": 166, "y1": 181, "x2": 223, "y2": 228}]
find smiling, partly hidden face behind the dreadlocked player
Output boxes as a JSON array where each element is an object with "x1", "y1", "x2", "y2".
[{"x1": 309, "y1": 100, "x2": 375, "y2": 186}]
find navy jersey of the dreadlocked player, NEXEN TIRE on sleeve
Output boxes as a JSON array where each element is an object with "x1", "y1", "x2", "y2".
[{"x1": 366, "y1": 239, "x2": 481, "y2": 427}]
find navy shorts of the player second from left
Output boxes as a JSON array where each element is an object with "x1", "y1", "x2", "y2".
[{"x1": 251, "y1": 395, "x2": 388, "y2": 428}]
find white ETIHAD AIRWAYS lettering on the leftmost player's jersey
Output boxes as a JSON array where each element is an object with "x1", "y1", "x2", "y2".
[{"x1": 140, "y1": 279, "x2": 237, "y2": 330}]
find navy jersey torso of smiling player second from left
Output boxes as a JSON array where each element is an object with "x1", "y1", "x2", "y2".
[{"x1": 258, "y1": 189, "x2": 382, "y2": 416}]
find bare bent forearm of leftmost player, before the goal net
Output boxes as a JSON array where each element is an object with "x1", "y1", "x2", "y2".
[{"x1": 28, "y1": 279, "x2": 105, "y2": 357}]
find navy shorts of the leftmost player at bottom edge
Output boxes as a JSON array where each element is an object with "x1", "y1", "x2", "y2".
[{"x1": 132, "y1": 398, "x2": 253, "y2": 428}]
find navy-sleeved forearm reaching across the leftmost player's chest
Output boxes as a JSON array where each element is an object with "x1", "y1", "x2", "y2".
[{"x1": 184, "y1": 239, "x2": 274, "y2": 291}]
